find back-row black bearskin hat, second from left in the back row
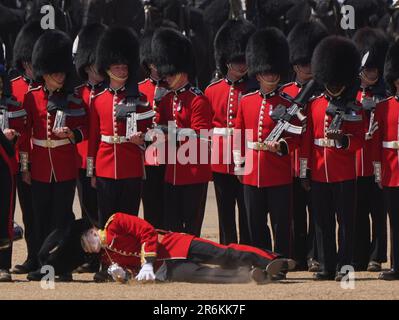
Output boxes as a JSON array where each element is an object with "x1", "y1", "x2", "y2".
[{"x1": 75, "y1": 23, "x2": 107, "y2": 79}]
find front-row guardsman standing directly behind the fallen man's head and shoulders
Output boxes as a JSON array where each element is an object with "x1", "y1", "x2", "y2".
[{"x1": 87, "y1": 27, "x2": 152, "y2": 227}]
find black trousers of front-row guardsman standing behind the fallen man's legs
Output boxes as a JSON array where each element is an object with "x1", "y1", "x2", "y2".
[{"x1": 244, "y1": 184, "x2": 292, "y2": 258}]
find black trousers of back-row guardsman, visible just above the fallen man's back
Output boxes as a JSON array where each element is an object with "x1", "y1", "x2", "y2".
[{"x1": 142, "y1": 165, "x2": 165, "y2": 229}]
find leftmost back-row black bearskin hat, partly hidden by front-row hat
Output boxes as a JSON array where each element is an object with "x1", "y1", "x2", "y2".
[{"x1": 13, "y1": 21, "x2": 44, "y2": 73}]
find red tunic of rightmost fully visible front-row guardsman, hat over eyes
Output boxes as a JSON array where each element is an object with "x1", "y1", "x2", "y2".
[{"x1": 300, "y1": 95, "x2": 364, "y2": 183}]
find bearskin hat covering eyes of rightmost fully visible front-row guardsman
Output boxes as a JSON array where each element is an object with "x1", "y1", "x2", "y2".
[{"x1": 312, "y1": 36, "x2": 360, "y2": 87}]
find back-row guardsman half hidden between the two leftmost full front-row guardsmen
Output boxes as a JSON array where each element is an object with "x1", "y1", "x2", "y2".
[{"x1": 75, "y1": 23, "x2": 106, "y2": 225}]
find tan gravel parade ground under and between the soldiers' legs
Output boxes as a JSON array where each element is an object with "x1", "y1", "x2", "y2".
[{"x1": 0, "y1": 185, "x2": 399, "y2": 300}]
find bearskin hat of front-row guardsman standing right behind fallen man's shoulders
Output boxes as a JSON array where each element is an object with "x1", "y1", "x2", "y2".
[{"x1": 96, "y1": 27, "x2": 139, "y2": 77}]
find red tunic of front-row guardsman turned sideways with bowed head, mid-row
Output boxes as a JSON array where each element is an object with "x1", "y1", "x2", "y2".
[{"x1": 158, "y1": 85, "x2": 212, "y2": 185}]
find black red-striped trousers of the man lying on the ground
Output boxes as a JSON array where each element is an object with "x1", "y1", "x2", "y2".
[{"x1": 167, "y1": 240, "x2": 276, "y2": 283}]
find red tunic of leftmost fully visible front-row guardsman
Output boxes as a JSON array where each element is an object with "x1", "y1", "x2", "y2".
[{"x1": 21, "y1": 86, "x2": 87, "y2": 183}]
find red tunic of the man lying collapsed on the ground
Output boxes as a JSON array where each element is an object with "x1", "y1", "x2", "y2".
[{"x1": 100, "y1": 213, "x2": 195, "y2": 270}]
